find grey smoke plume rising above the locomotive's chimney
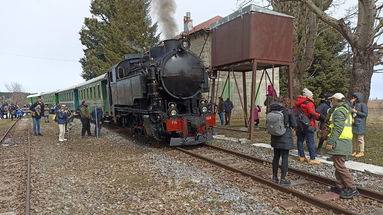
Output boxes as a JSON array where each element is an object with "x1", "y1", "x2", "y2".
[{"x1": 152, "y1": 0, "x2": 177, "y2": 39}]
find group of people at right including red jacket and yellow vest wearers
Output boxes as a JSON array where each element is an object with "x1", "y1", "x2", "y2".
[{"x1": 266, "y1": 88, "x2": 368, "y2": 199}]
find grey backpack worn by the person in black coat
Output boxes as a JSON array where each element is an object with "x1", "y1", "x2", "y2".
[{"x1": 266, "y1": 110, "x2": 287, "y2": 136}]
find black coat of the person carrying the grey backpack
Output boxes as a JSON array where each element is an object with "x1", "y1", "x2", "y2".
[{"x1": 271, "y1": 104, "x2": 297, "y2": 150}]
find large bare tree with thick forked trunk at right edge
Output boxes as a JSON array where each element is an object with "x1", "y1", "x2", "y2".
[{"x1": 297, "y1": 0, "x2": 383, "y2": 102}]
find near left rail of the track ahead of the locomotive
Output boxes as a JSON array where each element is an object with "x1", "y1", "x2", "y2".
[{"x1": 176, "y1": 147, "x2": 357, "y2": 215}]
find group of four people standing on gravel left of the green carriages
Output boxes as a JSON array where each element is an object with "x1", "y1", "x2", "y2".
[{"x1": 29, "y1": 97, "x2": 103, "y2": 142}]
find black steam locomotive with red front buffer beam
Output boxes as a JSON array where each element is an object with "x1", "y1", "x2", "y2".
[{"x1": 107, "y1": 39, "x2": 216, "y2": 146}]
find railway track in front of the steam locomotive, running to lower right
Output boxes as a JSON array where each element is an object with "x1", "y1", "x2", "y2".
[{"x1": 177, "y1": 144, "x2": 383, "y2": 214}]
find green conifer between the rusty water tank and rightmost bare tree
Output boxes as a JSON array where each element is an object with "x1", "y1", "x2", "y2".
[{"x1": 280, "y1": 26, "x2": 352, "y2": 99}]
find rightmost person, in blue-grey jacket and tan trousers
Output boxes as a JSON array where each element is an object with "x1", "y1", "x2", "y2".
[{"x1": 350, "y1": 92, "x2": 368, "y2": 157}]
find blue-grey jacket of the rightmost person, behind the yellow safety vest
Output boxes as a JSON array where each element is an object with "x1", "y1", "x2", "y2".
[{"x1": 351, "y1": 92, "x2": 368, "y2": 135}]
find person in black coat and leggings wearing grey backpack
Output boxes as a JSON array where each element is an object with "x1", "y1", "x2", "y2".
[{"x1": 266, "y1": 98, "x2": 297, "y2": 186}]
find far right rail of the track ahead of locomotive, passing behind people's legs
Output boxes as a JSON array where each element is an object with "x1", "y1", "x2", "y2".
[{"x1": 204, "y1": 143, "x2": 383, "y2": 202}]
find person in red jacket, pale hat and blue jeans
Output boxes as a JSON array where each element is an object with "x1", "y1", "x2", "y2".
[{"x1": 294, "y1": 88, "x2": 320, "y2": 164}]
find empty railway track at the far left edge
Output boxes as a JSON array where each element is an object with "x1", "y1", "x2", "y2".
[{"x1": 0, "y1": 120, "x2": 31, "y2": 215}]
